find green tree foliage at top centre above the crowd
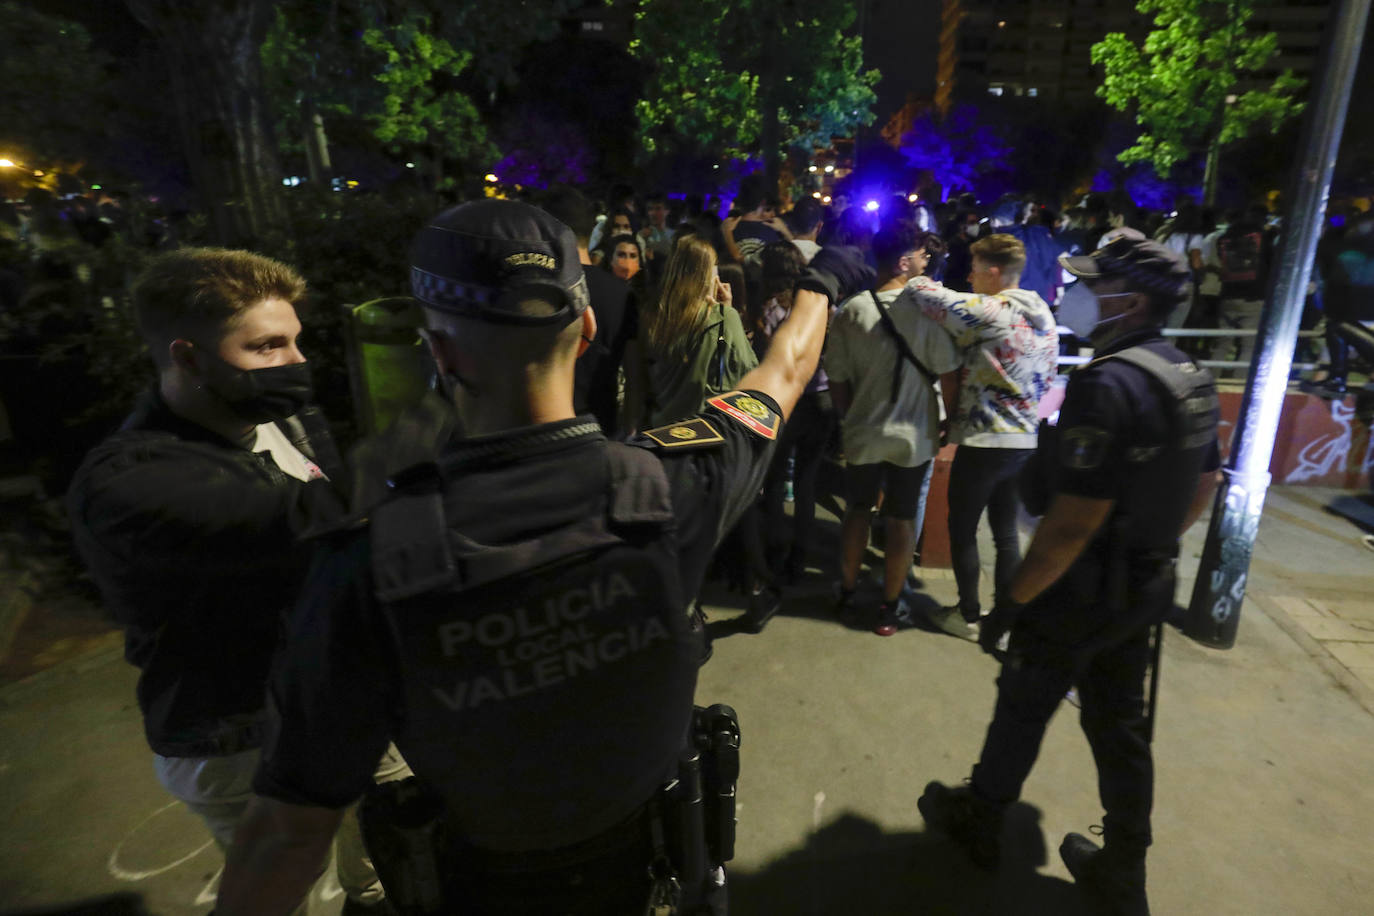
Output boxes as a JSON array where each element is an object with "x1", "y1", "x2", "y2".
[{"x1": 631, "y1": 0, "x2": 879, "y2": 157}]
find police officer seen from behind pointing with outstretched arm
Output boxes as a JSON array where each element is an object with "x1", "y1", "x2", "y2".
[{"x1": 217, "y1": 199, "x2": 871, "y2": 916}]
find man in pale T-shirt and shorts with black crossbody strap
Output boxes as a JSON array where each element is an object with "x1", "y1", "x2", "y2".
[{"x1": 826, "y1": 222, "x2": 959, "y2": 636}]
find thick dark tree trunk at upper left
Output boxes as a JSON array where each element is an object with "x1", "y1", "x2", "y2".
[{"x1": 125, "y1": 0, "x2": 286, "y2": 246}]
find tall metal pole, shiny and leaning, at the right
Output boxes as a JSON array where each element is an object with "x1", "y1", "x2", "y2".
[{"x1": 1183, "y1": 0, "x2": 1370, "y2": 648}]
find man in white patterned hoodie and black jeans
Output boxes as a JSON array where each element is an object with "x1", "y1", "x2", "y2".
[{"x1": 903, "y1": 233, "x2": 1059, "y2": 639}]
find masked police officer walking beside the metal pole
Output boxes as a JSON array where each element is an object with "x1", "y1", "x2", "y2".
[{"x1": 919, "y1": 233, "x2": 1219, "y2": 916}]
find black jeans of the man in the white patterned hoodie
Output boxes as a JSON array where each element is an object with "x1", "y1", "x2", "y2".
[{"x1": 949, "y1": 445, "x2": 1035, "y2": 615}]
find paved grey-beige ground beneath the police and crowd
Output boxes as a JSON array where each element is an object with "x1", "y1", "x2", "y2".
[{"x1": 0, "y1": 489, "x2": 1374, "y2": 916}]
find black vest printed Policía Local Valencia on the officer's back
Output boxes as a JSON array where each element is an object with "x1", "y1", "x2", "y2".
[{"x1": 372, "y1": 442, "x2": 702, "y2": 851}]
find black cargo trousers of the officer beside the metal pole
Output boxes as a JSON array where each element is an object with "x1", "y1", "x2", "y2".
[{"x1": 973, "y1": 559, "x2": 1173, "y2": 853}]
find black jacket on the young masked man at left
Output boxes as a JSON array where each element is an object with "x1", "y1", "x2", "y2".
[{"x1": 67, "y1": 393, "x2": 345, "y2": 757}]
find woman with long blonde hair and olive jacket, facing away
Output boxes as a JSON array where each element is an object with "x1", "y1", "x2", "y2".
[{"x1": 643, "y1": 235, "x2": 758, "y2": 426}]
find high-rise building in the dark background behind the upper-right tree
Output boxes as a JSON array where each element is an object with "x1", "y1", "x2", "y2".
[{"x1": 936, "y1": 0, "x2": 1330, "y2": 100}]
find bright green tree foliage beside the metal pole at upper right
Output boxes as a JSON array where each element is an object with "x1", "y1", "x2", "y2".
[{"x1": 1092, "y1": 0, "x2": 1305, "y2": 176}]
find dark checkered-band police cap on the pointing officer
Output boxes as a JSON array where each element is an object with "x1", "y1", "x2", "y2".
[{"x1": 411, "y1": 199, "x2": 589, "y2": 327}]
